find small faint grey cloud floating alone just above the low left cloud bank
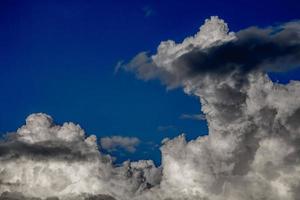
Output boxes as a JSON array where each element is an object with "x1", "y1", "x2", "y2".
[{"x1": 100, "y1": 136, "x2": 140, "y2": 153}]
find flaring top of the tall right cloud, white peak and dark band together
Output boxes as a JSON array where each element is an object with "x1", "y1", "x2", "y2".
[{"x1": 123, "y1": 17, "x2": 300, "y2": 88}]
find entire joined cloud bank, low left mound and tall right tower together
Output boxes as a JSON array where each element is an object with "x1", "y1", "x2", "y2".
[{"x1": 0, "y1": 17, "x2": 300, "y2": 200}]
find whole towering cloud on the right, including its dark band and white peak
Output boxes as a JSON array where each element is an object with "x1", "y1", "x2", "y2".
[{"x1": 123, "y1": 17, "x2": 300, "y2": 200}]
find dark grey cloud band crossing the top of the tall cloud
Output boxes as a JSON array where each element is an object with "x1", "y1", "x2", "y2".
[{"x1": 173, "y1": 22, "x2": 300, "y2": 74}]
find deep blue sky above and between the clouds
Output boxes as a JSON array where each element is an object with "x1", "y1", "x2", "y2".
[{"x1": 0, "y1": 0, "x2": 300, "y2": 162}]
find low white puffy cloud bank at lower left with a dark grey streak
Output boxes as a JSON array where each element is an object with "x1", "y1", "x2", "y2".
[{"x1": 0, "y1": 113, "x2": 161, "y2": 200}]
